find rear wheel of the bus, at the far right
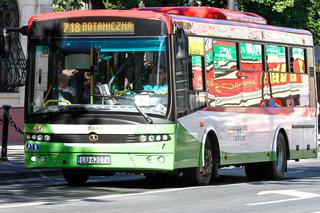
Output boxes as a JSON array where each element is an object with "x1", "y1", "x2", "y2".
[{"x1": 265, "y1": 133, "x2": 287, "y2": 180}]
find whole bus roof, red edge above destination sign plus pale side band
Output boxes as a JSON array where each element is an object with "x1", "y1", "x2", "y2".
[{"x1": 28, "y1": 7, "x2": 313, "y2": 46}]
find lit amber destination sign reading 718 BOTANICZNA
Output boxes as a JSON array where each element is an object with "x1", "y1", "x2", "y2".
[{"x1": 63, "y1": 21, "x2": 134, "y2": 34}]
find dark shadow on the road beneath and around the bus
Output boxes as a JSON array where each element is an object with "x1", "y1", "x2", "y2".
[{"x1": 0, "y1": 161, "x2": 320, "y2": 206}]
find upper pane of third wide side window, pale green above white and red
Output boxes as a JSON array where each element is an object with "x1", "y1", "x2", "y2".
[{"x1": 266, "y1": 45, "x2": 287, "y2": 72}]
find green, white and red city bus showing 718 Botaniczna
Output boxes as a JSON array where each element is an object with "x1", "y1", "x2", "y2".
[{"x1": 0, "y1": 7, "x2": 317, "y2": 185}]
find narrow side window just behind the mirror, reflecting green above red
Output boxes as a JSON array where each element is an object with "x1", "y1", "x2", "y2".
[{"x1": 191, "y1": 56, "x2": 204, "y2": 91}]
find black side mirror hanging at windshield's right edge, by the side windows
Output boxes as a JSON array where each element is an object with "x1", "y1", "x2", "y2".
[{"x1": 175, "y1": 25, "x2": 189, "y2": 60}]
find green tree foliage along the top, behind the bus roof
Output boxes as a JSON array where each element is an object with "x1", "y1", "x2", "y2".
[{"x1": 52, "y1": 0, "x2": 320, "y2": 44}]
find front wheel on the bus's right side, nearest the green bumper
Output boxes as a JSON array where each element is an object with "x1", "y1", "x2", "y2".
[{"x1": 183, "y1": 140, "x2": 214, "y2": 186}]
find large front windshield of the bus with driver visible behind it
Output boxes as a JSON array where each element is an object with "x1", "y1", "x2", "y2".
[{"x1": 27, "y1": 37, "x2": 169, "y2": 117}]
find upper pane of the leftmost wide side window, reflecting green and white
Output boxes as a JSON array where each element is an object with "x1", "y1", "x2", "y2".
[{"x1": 213, "y1": 41, "x2": 238, "y2": 71}]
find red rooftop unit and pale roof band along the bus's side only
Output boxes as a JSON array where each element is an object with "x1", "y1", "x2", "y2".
[{"x1": 135, "y1": 7, "x2": 313, "y2": 46}]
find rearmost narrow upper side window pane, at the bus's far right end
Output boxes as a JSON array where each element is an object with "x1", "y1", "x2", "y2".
[{"x1": 290, "y1": 47, "x2": 306, "y2": 73}]
